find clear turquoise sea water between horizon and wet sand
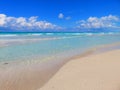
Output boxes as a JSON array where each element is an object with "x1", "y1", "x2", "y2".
[{"x1": 0, "y1": 33, "x2": 120, "y2": 62}]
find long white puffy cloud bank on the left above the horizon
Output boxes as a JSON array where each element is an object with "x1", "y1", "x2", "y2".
[{"x1": 0, "y1": 14, "x2": 61, "y2": 30}]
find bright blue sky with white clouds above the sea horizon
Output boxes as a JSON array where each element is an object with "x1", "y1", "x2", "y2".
[{"x1": 0, "y1": 0, "x2": 120, "y2": 32}]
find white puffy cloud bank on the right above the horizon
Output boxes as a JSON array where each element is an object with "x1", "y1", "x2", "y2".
[{"x1": 78, "y1": 15, "x2": 120, "y2": 28}]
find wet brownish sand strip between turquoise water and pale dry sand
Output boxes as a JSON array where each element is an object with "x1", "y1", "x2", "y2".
[{"x1": 0, "y1": 43, "x2": 120, "y2": 90}]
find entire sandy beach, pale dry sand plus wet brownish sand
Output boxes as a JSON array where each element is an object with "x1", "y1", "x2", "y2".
[{"x1": 0, "y1": 46, "x2": 120, "y2": 90}]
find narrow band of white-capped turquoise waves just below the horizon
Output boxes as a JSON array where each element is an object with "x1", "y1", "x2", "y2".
[{"x1": 0, "y1": 32, "x2": 120, "y2": 37}]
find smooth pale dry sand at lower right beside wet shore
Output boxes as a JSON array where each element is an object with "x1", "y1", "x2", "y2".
[{"x1": 38, "y1": 50, "x2": 120, "y2": 90}]
